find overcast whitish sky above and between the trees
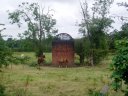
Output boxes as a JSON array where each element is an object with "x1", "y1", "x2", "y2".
[{"x1": 0, "y1": 0, "x2": 128, "y2": 38}]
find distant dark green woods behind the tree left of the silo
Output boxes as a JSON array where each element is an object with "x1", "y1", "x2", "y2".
[{"x1": 5, "y1": 37, "x2": 53, "y2": 52}]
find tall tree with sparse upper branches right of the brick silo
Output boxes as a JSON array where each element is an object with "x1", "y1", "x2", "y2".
[{"x1": 79, "y1": 0, "x2": 113, "y2": 66}]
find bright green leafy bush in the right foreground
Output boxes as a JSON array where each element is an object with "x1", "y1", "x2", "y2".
[{"x1": 111, "y1": 38, "x2": 128, "y2": 96}]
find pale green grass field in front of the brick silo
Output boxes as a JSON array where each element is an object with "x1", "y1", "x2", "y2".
[{"x1": 0, "y1": 53, "x2": 123, "y2": 96}]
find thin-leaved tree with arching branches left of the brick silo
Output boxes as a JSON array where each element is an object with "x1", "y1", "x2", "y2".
[{"x1": 9, "y1": 2, "x2": 57, "y2": 56}]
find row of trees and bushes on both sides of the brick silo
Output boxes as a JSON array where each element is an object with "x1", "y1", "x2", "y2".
[{"x1": 1, "y1": 0, "x2": 128, "y2": 66}]
